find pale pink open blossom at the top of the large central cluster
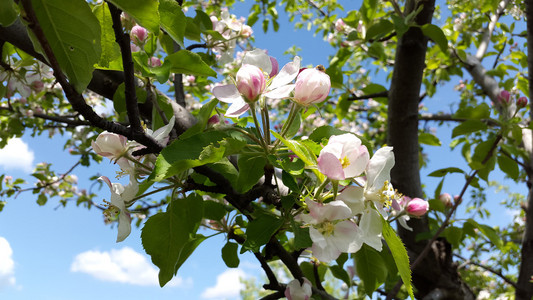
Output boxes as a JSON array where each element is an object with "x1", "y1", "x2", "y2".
[{"x1": 318, "y1": 133, "x2": 370, "y2": 180}]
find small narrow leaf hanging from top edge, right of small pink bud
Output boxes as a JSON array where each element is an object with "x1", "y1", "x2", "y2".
[{"x1": 159, "y1": 0, "x2": 187, "y2": 48}]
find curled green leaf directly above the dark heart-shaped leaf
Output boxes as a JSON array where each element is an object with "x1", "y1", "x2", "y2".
[{"x1": 153, "y1": 131, "x2": 246, "y2": 181}]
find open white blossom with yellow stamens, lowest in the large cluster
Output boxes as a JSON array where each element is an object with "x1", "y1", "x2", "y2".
[{"x1": 299, "y1": 199, "x2": 362, "y2": 262}]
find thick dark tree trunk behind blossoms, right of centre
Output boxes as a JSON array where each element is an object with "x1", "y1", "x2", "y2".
[{"x1": 387, "y1": 0, "x2": 474, "y2": 299}]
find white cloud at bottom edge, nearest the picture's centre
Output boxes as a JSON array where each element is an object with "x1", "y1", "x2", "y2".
[{"x1": 202, "y1": 269, "x2": 246, "y2": 300}]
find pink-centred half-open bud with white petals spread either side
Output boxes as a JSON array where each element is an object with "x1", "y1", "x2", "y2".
[{"x1": 236, "y1": 64, "x2": 266, "y2": 102}]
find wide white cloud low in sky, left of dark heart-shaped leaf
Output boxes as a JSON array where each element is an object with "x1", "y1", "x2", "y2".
[{"x1": 70, "y1": 247, "x2": 188, "y2": 286}]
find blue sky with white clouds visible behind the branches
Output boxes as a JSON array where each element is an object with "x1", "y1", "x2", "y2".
[{"x1": 0, "y1": 1, "x2": 523, "y2": 300}]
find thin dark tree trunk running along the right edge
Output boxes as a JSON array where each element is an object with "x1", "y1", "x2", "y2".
[{"x1": 515, "y1": 0, "x2": 533, "y2": 300}]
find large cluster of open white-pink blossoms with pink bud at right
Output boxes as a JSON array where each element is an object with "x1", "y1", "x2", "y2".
[{"x1": 298, "y1": 134, "x2": 428, "y2": 262}]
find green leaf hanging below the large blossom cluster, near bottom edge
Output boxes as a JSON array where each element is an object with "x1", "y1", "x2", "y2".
[{"x1": 354, "y1": 244, "x2": 387, "y2": 296}]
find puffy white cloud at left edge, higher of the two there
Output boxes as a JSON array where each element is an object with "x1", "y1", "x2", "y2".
[{"x1": 0, "y1": 138, "x2": 34, "y2": 172}]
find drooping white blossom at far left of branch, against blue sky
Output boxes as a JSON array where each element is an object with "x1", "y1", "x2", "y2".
[{"x1": 98, "y1": 176, "x2": 139, "y2": 243}]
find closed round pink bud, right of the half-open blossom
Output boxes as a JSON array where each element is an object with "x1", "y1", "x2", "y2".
[{"x1": 294, "y1": 66, "x2": 331, "y2": 106}]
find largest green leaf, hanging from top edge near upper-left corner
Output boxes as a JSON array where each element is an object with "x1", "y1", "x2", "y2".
[{"x1": 32, "y1": 0, "x2": 101, "y2": 93}]
